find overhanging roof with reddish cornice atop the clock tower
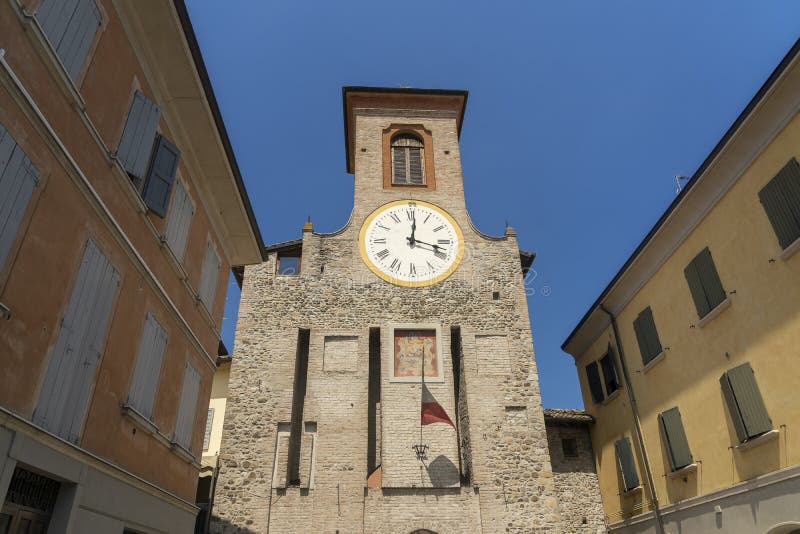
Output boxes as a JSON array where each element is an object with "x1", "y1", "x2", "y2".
[{"x1": 342, "y1": 86, "x2": 469, "y2": 174}]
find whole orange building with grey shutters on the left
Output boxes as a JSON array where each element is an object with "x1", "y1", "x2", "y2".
[{"x1": 0, "y1": 0, "x2": 263, "y2": 533}]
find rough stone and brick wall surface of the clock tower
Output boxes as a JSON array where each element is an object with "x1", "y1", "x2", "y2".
[{"x1": 212, "y1": 110, "x2": 561, "y2": 533}]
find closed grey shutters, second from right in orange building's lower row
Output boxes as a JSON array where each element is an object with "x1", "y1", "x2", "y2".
[{"x1": 128, "y1": 313, "x2": 167, "y2": 420}]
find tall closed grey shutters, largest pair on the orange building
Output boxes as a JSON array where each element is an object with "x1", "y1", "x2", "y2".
[{"x1": 33, "y1": 240, "x2": 120, "y2": 443}]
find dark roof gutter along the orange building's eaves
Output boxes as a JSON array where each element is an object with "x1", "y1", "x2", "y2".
[{"x1": 173, "y1": 0, "x2": 267, "y2": 261}]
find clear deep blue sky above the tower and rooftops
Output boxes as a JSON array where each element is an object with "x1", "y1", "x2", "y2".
[{"x1": 187, "y1": 0, "x2": 800, "y2": 407}]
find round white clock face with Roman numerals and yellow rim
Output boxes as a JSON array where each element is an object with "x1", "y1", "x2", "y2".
[{"x1": 360, "y1": 200, "x2": 464, "y2": 287}]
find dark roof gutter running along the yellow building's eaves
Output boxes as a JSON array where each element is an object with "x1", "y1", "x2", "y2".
[{"x1": 561, "y1": 39, "x2": 800, "y2": 352}]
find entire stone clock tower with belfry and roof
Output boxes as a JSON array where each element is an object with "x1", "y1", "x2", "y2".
[{"x1": 212, "y1": 87, "x2": 562, "y2": 534}]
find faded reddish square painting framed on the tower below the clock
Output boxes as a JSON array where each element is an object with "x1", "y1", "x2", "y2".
[{"x1": 393, "y1": 329, "x2": 441, "y2": 381}]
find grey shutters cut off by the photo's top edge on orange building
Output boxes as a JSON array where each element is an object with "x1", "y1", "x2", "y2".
[{"x1": 36, "y1": 0, "x2": 103, "y2": 80}]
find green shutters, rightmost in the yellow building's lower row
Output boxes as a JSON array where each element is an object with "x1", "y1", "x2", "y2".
[{"x1": 720, "y1": 363, "x2": 772, "y2": 443}]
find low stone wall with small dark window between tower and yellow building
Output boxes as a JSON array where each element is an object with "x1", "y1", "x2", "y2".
[{"x1": 547, "y1": 421, "x2": 606, "y2": 534}]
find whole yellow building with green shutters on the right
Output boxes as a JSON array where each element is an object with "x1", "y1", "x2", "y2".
[{"x1": 562, "y1": 38, "x2": 800, "y2": 534}]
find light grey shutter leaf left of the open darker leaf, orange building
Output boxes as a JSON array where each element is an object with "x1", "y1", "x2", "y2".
[{"x1": 117, "y1": 91, "x2": 161, "y2": 182}]
